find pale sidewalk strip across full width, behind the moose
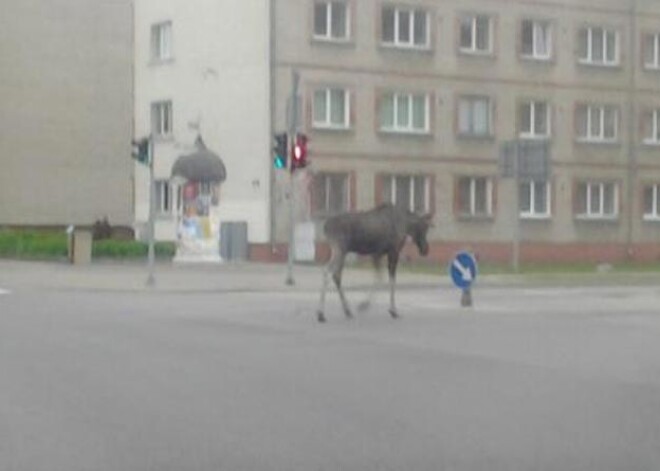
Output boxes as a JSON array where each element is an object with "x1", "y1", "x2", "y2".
[{"x1": 0, "y1": 260, "x2": 660, "y2": 293}]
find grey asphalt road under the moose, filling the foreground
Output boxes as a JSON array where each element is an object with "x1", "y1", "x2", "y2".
[{"x1": 0, "y1": 287, "x2": 660, "y2": 471}]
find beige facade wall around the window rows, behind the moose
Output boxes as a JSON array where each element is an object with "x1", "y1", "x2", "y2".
[{"x1": 274, "y1": 0, "x2": 660, "y2": 247}]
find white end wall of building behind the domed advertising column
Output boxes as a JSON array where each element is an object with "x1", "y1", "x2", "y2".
[{"x1": 134, "y1": 0, "x2": 271, "y2": 249}]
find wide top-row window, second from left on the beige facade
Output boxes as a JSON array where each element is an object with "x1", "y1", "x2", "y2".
[{"x1": 382, "y1": 6, "x2": 430, "y2": 49}]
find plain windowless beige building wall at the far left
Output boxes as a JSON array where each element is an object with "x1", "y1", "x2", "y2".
[{"x1": 0, "y1": 0, "x2": 133, "y2": 228}]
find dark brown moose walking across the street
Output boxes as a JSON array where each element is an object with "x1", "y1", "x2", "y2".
[{"x1": 317, "y1": 203, "x2": 432, "y2": 322}]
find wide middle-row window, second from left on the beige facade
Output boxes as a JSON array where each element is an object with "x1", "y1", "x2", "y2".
[{"x1": 380, "y1": 93, "x2": 430, "y2": 134}]
